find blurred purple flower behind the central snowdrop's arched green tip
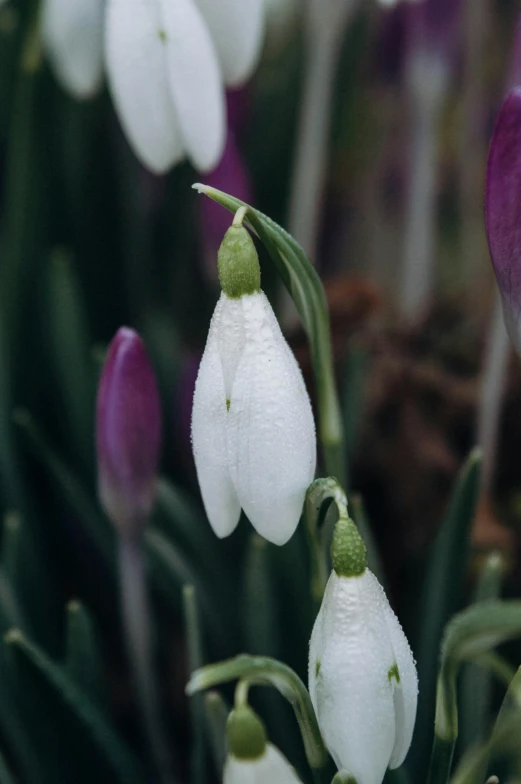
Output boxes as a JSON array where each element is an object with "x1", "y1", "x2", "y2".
[{"x1": 200, "y1": 131, "x2": 252, "y2": 281}]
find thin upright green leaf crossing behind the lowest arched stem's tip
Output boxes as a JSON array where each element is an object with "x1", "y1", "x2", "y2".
[{"x1": 183, "y1": 585, "x2": 206, "y2": 784}]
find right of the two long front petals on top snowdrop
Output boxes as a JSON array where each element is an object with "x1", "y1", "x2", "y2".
[{"x1": 157, "y1": 0, "x2": 226, "y2": 172}]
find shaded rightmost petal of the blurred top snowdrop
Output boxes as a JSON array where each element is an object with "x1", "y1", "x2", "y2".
[{"x1": 196, "y1": 0, "x2": 264, "y2": 86}]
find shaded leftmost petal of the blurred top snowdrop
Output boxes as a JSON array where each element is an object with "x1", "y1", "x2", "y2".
[{"x1": 42, "y1": 0, "x2": 105, "y2": 99}]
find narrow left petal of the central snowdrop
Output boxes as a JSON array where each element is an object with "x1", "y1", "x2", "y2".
[{"x1": 192, "y1": 298, "x2": 241, "y2": 538}]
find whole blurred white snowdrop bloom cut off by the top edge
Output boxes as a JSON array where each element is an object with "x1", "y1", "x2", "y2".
[{"x1": 42, "y1": 0, "x2": 264, "y2": 173}]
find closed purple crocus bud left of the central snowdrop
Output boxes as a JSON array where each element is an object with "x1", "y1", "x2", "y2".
[{"x1": 96, "y1": 327, "x2": 161, "y2": 535}]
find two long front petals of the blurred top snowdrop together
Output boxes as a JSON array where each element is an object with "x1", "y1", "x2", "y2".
[{"x1": 105, "y1": 0, "x2": 225, "y2": 173}]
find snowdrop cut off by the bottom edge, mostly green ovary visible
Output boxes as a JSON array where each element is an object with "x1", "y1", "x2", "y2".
[{"x1": 223, "y1": 706, "x2": 302, "y2": 784}]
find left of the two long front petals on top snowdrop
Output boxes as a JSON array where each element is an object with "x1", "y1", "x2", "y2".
[{"x1": 105, "y1": 0, "x2": 183, "y2": 173}]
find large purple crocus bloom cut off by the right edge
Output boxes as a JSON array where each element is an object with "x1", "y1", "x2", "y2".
[{"x1": 485, "y1": 89, "x2": 521, "y2": 353}]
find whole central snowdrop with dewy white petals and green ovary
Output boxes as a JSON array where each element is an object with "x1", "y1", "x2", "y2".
[{"x1": 192, "y1": 209, "x2": 316, "y2": 545}]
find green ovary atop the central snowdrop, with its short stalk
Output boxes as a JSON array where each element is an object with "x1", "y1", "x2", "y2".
[{"x1": 217, "y1": 207, "x2": 260, "y2": 299}]
